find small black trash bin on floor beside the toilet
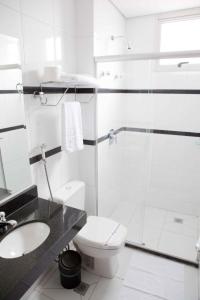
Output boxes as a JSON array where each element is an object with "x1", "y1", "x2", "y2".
[{"x1": 59, "y1": 250, "x2": 81, "y2": 289}]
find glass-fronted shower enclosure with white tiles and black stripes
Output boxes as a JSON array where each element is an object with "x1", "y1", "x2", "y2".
[{"x1": 96, "y1": 51, "x2": 200, "y2": 263}]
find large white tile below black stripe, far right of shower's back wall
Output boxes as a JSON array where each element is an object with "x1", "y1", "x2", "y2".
[{"x1": 148, "y1": 135, "x2": 200, "y2": 215}]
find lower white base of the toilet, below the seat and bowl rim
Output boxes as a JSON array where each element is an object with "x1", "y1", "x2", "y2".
[{"x1": 80, "y1": 252, "x2": 119, "y2": 278}]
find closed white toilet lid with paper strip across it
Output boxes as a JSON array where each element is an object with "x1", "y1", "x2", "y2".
[{"x1": 74, "y1": 216, "x2": 127, "y2": 250}]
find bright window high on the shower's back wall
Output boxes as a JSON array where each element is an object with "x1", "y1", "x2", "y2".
[{"x1": 159, "y1": 15, "x2": 200, "y2": 70}]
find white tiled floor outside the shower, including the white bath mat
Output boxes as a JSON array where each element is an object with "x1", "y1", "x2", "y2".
[{"x1": 21, "y1": 248, "x2": 198, "y2": 300}]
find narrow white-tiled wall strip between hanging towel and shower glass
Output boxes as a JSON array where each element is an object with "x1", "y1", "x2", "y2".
[{"x1": 74, "y1": 0, "x2": 97, "y2": 215}]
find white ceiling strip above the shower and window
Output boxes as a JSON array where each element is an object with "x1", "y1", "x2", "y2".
[{"x1": 111, "y1": 0, "x2": 200, "y2": 18}]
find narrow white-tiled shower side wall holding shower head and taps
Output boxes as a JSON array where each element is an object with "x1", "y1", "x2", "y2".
[{"x1": 94, "y1": 0, "x2": 126, "y2": 216}]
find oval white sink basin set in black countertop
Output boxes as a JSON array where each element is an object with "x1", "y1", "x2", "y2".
[{"x1": 0, "y1": 222, "x2": 50, "y2": 258}]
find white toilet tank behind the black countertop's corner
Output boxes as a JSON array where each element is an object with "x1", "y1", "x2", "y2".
[{"x1": 53, "y1": 180, "x2": 85, "y2": 210}]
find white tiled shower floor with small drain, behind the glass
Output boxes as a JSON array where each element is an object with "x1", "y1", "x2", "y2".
[{"x1": 111, "y1": 202, "x2": 200, "y2": 262}]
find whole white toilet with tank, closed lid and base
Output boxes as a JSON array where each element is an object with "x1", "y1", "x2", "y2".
[{"x1": 54, "y1": 181, "x2": 127, "y2": 278}]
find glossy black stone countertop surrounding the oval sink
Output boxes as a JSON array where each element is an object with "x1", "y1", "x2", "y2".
[{"x1": 0, "y1": 188, "x2": 86, "y2": 300}]
